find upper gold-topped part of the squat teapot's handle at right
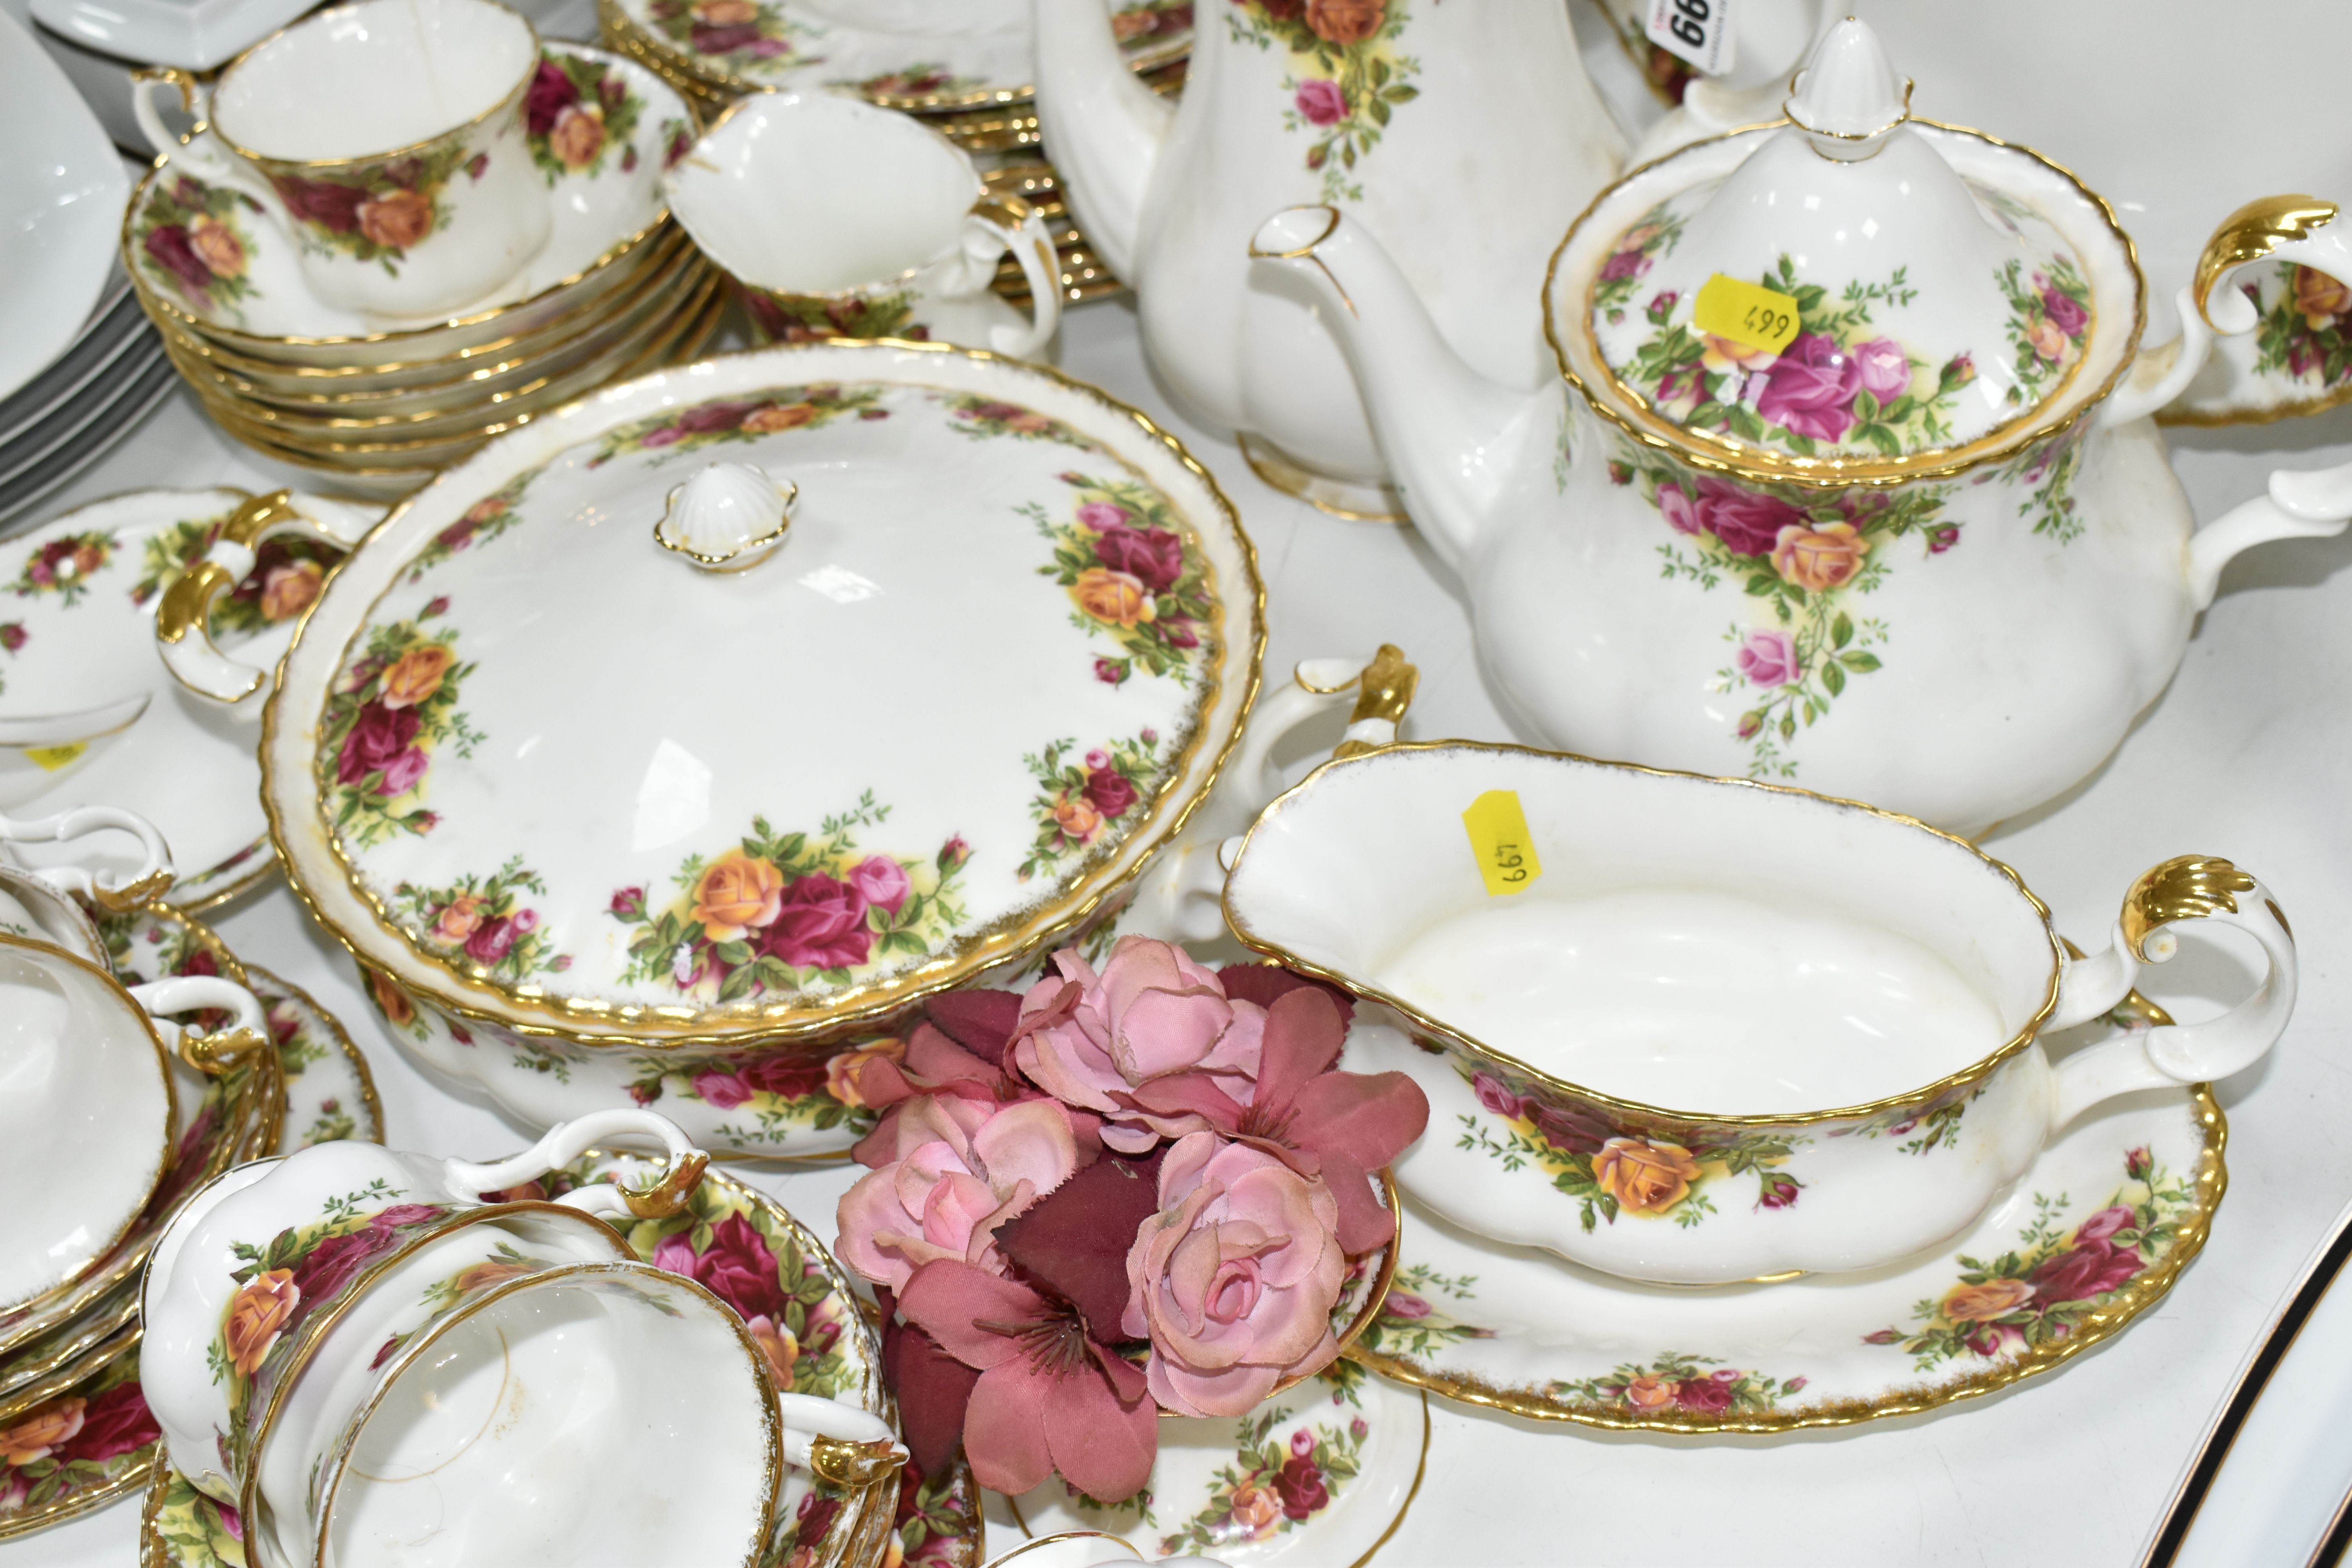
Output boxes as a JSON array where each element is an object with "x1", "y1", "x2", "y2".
[{"x1": 2098, "y1": 195, "x2": 2352, "y2": 428}]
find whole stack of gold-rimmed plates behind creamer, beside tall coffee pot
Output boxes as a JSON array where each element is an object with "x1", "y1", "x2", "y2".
[{"x1": 597, "y1": 0, "x2": 1192, "y2": 303}]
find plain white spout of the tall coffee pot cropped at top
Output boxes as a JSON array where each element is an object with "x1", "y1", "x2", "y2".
[{"x1": 1033, "y1": 0, "x2": 1176, "y2": 282}]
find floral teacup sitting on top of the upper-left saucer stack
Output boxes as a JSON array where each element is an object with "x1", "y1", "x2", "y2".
[{"x1": 132, "y1": 0, "x2": 553, "y2": 320}]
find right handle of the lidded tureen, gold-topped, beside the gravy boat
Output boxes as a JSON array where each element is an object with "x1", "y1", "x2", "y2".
[{"x1": 1120, "y1": 642, "x2": 1421, "y2": 943}]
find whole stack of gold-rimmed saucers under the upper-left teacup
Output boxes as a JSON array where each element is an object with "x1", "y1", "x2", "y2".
[{"x1": 122, "y1": 42, "x2": 724, "y2": 496}]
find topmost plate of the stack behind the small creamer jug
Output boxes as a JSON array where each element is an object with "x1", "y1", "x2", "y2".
[{"x1": 597, "y1": 0, "x2": 1195, "y2": 113}]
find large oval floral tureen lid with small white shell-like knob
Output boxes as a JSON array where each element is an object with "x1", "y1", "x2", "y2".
[{"x1": 263, "y1": 346, "x2": 1261, "y2": 1039}]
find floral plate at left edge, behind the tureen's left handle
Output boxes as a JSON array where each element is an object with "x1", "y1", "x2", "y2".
[{"x1": 0, "y1": 489, "x2": 367, "y2": 910}]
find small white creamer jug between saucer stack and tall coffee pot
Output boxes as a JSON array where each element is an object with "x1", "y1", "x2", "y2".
[{"x1": 663, "y1": 92, "x2": 1061, "y2": 358}]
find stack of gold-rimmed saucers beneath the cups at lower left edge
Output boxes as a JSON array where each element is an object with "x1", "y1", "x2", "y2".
[{"x1": 0, "y1": 905, "x2": 383, "y2": 1542}]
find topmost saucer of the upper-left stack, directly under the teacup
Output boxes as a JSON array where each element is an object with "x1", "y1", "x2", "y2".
[{"x1": 122, "y1": 42, "x2": 694, "y2": 365}]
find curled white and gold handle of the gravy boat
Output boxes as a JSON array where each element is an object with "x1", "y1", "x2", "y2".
[{"x1": 2046, "y1": 856, "x2": 2296, "y2": 1131}]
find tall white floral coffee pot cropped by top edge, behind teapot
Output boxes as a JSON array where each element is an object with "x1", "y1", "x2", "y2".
[{"x1": 1035, "y1": 0, "x2": 1625, "y2": 515}]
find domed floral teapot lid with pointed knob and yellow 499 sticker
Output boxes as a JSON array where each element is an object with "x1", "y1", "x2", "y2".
[{"x1": 1545, "y1": 16, "x2": 2138, "y2": 479}]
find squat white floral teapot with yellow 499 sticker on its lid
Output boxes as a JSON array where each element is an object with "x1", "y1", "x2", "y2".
[{"x1": 1251, "y1": 19, "x2": 2352, "y2": 832}]
